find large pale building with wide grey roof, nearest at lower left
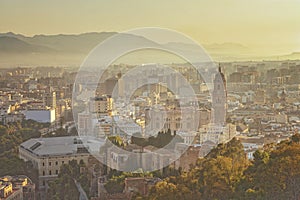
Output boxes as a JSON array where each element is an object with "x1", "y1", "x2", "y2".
[{"x1": 19, "y1": 136, "x2": 103, "y2": 189}]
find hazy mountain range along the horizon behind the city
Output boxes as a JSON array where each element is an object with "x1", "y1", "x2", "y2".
[{"x1": 0, "y1": 32, "x2": 300, "y2": 67}]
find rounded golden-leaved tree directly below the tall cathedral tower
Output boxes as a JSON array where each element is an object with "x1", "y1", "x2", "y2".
[{"x1": 197, "y1": 138, "x2": 249, "y2": 199}]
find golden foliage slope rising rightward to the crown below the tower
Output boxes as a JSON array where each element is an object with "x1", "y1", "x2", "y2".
[{"x1": 148, "y1": 139, "x2": 249, "y2": 200}]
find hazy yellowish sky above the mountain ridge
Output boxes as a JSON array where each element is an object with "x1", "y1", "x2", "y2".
[{"x1": 0, "y1": 0, "x2": 300, "y2": 51}]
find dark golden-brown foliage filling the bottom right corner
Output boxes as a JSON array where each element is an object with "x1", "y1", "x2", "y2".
[{"x1": 239, "y1": 139, "x2": 300, "y2": 199}]
